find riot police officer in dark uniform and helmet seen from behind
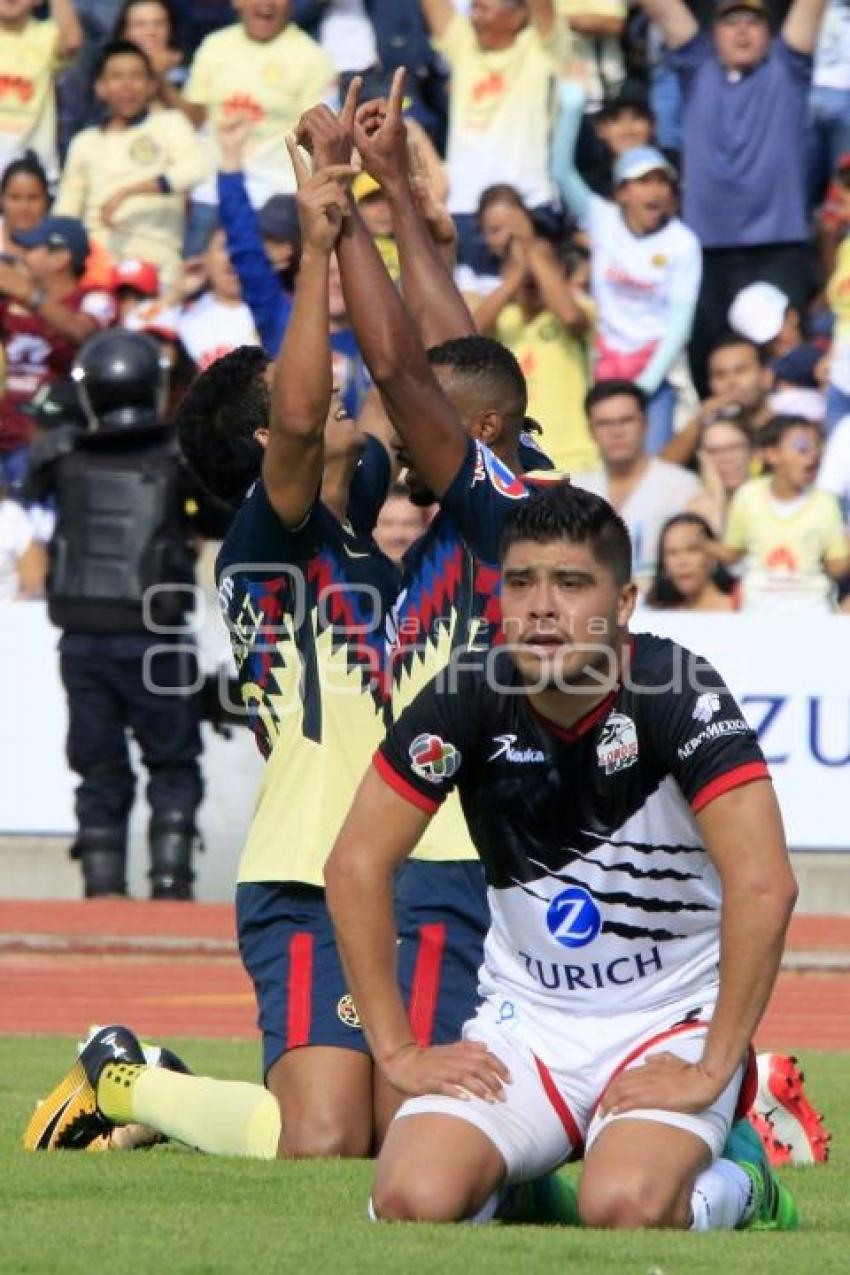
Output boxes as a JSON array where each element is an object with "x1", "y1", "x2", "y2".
[{"x1": 28, "y1": 329, "x2": 211, "y2": 899}]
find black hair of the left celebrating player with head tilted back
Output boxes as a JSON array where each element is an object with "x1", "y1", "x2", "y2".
[{"x1": 175, "y1": 346, "x2": 271, "y2": 509}]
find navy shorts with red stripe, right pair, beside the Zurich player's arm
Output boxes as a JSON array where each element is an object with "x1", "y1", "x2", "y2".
[{"x1": 396, "y1": 859, "x2": 489, "y2": 1046}]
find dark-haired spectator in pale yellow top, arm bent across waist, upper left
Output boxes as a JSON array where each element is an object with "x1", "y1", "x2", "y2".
[{"x1": 55, "y1": 41, "x2": 208, "y2": 289}]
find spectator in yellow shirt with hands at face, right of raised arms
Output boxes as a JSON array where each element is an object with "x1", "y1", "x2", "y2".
[{"x1": 473, "y1": 186, "x2": 599, "y2": 473}]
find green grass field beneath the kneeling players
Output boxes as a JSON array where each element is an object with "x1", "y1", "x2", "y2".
[{"x1": 0, "y1": 1037, "x2": 850, "y2": 1275}]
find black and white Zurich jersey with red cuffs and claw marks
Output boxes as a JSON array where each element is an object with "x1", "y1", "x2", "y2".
[{"x1": 375, "y1": 634, "x2": 768, "y2": 1014}]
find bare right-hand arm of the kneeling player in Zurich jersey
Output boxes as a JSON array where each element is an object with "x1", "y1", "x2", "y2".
[{"x1": 697, "y1": 779, "x2": 796, "y2": 1093}]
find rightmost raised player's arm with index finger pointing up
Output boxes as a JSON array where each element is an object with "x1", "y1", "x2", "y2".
[{"x1": 354, "y1": 68, "x2": 475, "y2": 346}]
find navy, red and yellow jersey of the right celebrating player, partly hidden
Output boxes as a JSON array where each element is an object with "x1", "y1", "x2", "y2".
[{"x1": 387, "y1": 439, "x2": 563, "y2": 861}]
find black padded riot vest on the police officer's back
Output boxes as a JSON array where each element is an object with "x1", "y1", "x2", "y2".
[{"x1": 47, "y1": 436, "x2": 196, "y2": 641}]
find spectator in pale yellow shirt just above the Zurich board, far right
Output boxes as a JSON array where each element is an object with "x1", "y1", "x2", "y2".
[{"x1": 712, "y1": 416, "x2": 850, "y2": 612}]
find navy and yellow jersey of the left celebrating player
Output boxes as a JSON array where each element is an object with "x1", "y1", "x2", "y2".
[{"x1": 221, "y1": 482, "x2": 399, "y2": 885}]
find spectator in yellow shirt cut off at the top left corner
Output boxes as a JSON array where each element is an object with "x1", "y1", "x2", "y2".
[{"x1": 0, "y1": 0, "x2": 83, "y2": 180}]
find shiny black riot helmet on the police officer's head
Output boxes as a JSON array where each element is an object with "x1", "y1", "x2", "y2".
[{"x1": 71, "y1": 328, "x2": 168, "y2": 435}]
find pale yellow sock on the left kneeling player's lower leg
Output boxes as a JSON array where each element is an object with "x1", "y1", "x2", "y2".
[{"x1": 97, "y1": 1063, "x2": 280, "y2": 1160}]
